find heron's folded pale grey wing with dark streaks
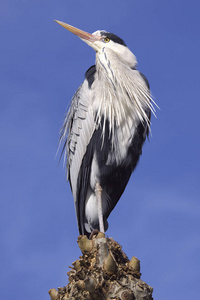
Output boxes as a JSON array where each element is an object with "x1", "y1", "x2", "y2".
[{"x1": 60, "y1": 80, "x2": 95, "y2": 205}]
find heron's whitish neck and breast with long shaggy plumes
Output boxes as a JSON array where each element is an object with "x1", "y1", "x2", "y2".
[{"x1": 93, "y1": 48, "x2": 151, "y2": 131}]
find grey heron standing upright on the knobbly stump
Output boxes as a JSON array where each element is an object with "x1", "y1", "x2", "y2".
[{"x1": 55, "y1": 20, "x2": 156, "y2": 237}]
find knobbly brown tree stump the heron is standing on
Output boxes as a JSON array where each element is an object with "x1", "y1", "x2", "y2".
[{"x1": 49, "y1": 232, "x2": 153, "y2": 300}]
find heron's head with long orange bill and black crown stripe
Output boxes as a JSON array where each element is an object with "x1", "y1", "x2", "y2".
[{"x1": 55, "y1": 20, "x2": 137, "y2": 68}]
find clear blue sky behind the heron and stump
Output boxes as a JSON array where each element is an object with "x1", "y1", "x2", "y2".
[{"x1": 0, "y1": 0, "x2": 200, "y2": 300}]
